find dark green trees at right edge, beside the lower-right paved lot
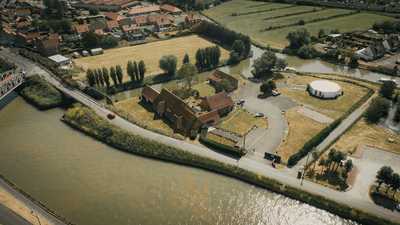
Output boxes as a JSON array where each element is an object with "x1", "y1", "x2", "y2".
[{"x1": 376, "y1": 166, "x2": 400, "y2": 197}]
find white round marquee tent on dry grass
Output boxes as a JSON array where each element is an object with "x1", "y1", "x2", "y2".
[{"x1": 308, "y1": 80, "x2": 343, "y2": 99}]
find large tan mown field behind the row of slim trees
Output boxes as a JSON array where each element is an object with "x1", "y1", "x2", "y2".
[{"x1": 74, "y1": 35, "x2": 229, "y2": 81}]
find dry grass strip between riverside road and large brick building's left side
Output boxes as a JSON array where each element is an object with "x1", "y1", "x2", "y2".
[{"x1": 115, "y1": 97, "x2": 182, "y2": 136}]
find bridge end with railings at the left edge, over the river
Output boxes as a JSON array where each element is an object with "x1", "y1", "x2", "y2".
[{"x1": 0, "y1": 70, "x2": 25, "y2": 100}]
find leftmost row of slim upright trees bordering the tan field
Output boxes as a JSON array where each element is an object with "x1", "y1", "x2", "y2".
[{"x1": 86, "y1": 65, "x2": 123, "y2": 88}]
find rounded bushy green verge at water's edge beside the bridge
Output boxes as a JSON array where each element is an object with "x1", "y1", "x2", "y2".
[{"x1": 20, "y1": 75, "x2": 65, "y2": 110}]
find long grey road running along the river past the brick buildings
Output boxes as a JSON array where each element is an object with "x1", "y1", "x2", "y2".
[{"x1": 0, "y1": 48, "x2": 400, "y2": 224}]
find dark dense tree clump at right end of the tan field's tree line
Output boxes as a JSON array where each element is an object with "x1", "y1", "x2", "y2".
[{"x1": 196, "y1": 46, "x2": 221, "y2": 71}]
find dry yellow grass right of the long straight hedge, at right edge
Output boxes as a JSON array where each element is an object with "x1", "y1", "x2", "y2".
[{"x1": 334, "y1": 119, "x2": 400, "y2": 153}]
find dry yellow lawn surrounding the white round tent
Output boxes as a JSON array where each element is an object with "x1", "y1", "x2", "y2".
[{"x1": 279, "y1": 76, "x2": 368, "y2": 119}]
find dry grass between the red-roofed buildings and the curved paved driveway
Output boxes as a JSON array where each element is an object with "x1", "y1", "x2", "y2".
[{"x1": 218, "y1": 109, "x2": 268, "y2": 136}]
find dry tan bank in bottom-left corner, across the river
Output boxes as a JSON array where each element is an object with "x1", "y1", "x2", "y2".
[{"x1": 0, "y1": 175, "x2": 72, "y2": 225}]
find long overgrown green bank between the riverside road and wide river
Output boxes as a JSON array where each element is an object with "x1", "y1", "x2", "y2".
[{"x1": 63, "y1": 106, "x2": 399, "y2": 225}]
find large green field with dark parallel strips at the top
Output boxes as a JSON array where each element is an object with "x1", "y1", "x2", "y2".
[{"x1": 204, "y1": 0, "x2": 393, "y2": 49}]
